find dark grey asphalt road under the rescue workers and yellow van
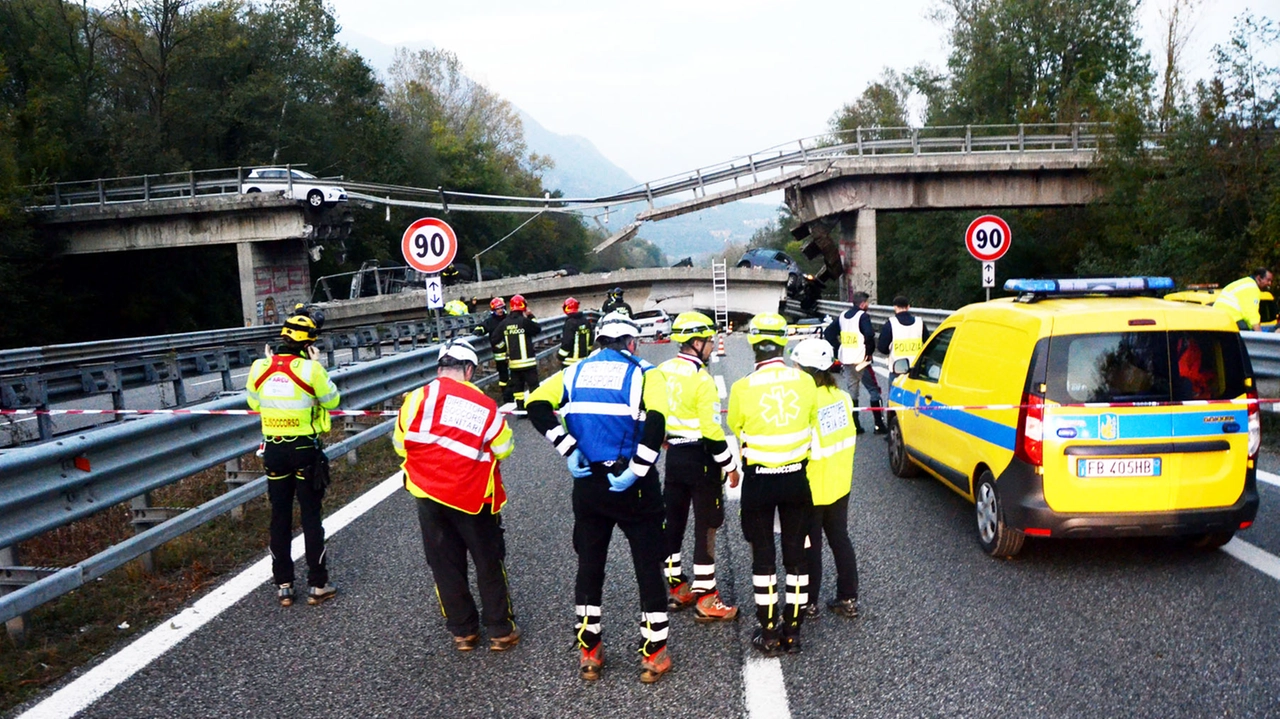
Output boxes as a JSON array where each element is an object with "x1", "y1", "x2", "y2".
[{"x1": 15, "y1": 338, "x2": 1280, "y2": 718}]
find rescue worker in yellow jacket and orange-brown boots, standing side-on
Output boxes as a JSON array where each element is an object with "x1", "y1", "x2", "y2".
[{"x1": 658, "y1": 312, "x2": 739, "y2": 622}]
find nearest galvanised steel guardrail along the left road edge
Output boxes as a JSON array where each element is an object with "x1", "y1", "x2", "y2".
[{"x1": 0, "y1": 316, "x2": 564, "y2": 622}]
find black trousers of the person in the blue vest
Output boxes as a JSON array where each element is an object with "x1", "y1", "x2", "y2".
[{"x1": 573, "y1": 466, "x2": 667, "y2": 655}]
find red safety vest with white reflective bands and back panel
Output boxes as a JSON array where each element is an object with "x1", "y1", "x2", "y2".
[{"x1": 404, "y1": 377, "x2": 507, "y2": 514}]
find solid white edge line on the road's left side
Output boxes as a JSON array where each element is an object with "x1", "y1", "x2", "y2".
[{"x1": 19, "y1": 472, "x2": 403, "y2": 719}]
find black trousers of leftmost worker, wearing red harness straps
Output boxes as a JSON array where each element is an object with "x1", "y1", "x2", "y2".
[{"x1": 262, "y1": 436, "x2": 329, "y2": 587}]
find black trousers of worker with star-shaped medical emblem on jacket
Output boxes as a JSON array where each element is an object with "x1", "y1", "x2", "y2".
[{"x1": 741, "y1": 462, "x2": 813, "y2": 631}]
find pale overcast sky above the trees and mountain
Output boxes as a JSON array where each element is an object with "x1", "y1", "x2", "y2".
[{"x1": 329, "y1": 0, "x2": 1264, "y2": 182}]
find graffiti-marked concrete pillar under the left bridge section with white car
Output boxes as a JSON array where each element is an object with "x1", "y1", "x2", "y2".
[{"x1": 236, "y1": 239, "x2": 311, "y2": 326}]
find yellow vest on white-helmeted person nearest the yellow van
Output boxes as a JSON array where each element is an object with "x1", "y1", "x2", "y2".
[{"x1": 805, "y1": 386, "x2": 858, "y2": 505}]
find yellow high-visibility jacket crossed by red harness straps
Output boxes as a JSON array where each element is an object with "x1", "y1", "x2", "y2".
[{"x1": 244, "y1": 354, "x2": 340, "y2": 436}]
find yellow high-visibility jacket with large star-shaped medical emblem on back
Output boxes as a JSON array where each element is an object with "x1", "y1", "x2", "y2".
[{"x1": 728, "y1": 360, "x2": 817, "y2": 467}]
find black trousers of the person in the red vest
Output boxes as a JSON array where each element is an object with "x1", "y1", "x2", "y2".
[{"x1": 417, "y1": 498, "x2": 516, "y2": 638}]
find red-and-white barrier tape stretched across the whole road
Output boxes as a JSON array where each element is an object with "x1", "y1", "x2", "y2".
[{"x1": 0, "y1": 398, "x2": 1280, "y2": 417}]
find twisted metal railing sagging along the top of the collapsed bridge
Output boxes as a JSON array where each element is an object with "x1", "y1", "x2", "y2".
[{"x1": 28, "y1": 123, "x2": 1131, "y2": 212}]
